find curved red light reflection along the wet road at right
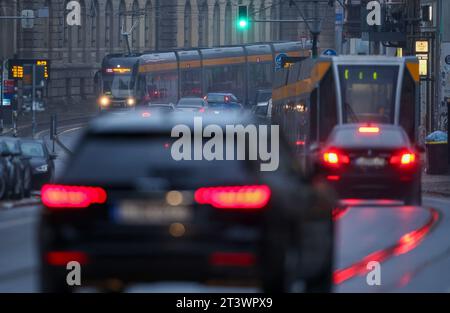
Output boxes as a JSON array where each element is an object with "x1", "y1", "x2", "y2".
[{"x1": 333, "y1": 209, "x2": 439, "y2": 284}]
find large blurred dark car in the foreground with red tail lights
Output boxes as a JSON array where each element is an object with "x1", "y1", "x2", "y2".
[{"x1": 40, "y1": 112, "x2": 334, "y2": 292}]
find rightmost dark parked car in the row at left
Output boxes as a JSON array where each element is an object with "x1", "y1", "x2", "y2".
[{"x1": 20, "y1": 139, "x2": 56, "y2": 190}]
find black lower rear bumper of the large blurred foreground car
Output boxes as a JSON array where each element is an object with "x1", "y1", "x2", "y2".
[{"x1": 41, "y1": 239, "x2": 260, "y2": 284}]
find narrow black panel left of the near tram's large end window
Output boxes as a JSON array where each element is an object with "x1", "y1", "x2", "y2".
[{"x1": 319, "y1": 70, "x2": 337, "y2": 141}]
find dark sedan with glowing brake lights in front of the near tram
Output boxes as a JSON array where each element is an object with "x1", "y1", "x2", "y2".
[{"x1": 315, "y1": 124, "x2": 422, "y2": 205}]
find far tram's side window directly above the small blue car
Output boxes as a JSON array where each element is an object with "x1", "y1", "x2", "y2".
[{"x1": 204, "y1": 64, "x2": 245, "y2": 99}]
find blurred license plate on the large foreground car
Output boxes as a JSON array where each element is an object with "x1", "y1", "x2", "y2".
[{"x1": 114, "y1": 200, "x2": 192, "y2": 225}]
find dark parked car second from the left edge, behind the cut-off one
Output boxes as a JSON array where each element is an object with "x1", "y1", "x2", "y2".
[{"x1": 0, "y1": 137, "x2": 32, "y2": 199}]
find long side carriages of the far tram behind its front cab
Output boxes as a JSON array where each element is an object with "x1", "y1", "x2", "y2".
[{"x1": 136, "y1": 42, "x2": 310, "y2": 104}]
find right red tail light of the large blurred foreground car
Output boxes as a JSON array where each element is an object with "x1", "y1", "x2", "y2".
[{"x1": 194, "y1": 185, "x2": 271, "y2": 209}]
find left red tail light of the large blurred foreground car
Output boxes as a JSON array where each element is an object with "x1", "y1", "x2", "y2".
[{"x1": 41, "y1": 185, "x2": 107, "y2": 209}]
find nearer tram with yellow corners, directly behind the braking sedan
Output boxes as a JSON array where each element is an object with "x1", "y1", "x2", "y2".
[{"x1": 272, "y1": 55, "x2": 420, "y2": 158}]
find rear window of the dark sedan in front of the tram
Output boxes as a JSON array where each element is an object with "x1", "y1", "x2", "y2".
[{"x1": 330, "y1": 128, "x2": 408, "y2": 148}]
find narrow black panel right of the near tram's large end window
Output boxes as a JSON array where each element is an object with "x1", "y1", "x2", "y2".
[{"x1": 400, "y1": 71, "x2": 416, "y2": 142}]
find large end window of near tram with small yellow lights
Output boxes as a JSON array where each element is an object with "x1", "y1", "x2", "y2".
[{"x1": 339, "y1": 65, "x2": 399, "y2": 123}]
